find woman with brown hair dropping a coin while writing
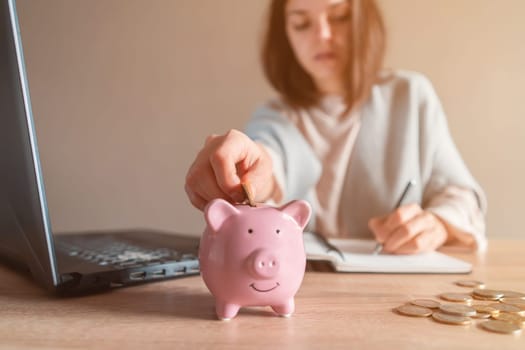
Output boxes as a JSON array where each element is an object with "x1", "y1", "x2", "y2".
[{"x1": 185, "y1": 0, "x2": 486, "y2": 254}]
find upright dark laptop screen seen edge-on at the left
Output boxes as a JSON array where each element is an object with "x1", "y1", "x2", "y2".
[{"x1": 0, "y1": 0, "x2": 58, "y2": 287}]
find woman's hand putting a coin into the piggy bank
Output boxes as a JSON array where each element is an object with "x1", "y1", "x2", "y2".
[{"x1": 184, "y1": 130, "x2": 274, "y2": 210}]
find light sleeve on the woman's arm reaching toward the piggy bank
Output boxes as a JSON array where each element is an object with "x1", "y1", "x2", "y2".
[{"x1": 245, "y1": 102, "x2": 321, "y2": 203}]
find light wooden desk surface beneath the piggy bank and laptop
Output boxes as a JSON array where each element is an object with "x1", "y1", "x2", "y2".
[{"x1": 0, "y1": 240, "x2": 525, "y2": 350}]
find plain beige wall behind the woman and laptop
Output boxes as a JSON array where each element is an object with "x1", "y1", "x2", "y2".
[{"x1": 18, "y1": 0, "x2": 525, "y2": 238}]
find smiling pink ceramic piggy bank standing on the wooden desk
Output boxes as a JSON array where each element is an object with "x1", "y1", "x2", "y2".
[{"x1": 199, "y1": 199, "x2": 312, "y2": 320}]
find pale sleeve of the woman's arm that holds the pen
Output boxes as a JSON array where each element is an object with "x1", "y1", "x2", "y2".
[{"x1": 418, "y1": 78, "x2": 487, "y2": 251}]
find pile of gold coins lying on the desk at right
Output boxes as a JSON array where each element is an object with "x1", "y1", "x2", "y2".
[{"x1": 394, "y1": 280, "x2": 525, "y2": 334}]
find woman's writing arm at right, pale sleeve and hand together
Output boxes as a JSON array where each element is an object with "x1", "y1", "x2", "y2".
[{"x1": 369, "y1": 76, "x2": 486, "y2": 254}]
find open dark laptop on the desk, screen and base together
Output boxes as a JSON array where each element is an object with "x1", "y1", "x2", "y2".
[{"x1": 0, "y1": 0, "x2": 199, "y2": 294}]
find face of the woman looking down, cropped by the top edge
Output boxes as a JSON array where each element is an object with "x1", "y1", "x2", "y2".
[{"x1": 285, "y1": 0, "x2": 351, "y2": 93}]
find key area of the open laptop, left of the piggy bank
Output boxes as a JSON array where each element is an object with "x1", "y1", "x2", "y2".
[{"x1": 56, "y1": 237, "x2": 197, "y2": 268}]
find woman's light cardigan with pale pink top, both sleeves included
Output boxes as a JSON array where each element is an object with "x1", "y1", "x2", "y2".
[{"x1": 246, "y1": 71, "x2": 487, "y2": 250}]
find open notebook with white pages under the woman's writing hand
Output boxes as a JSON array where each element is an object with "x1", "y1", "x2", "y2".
[{"x1": 304, "y1": 232, "x2": 472, "y2": 273}]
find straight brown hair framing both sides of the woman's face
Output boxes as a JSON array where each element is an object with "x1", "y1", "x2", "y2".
[{"x1": 261, "y1": 0, "x2": 386, "y2": 110}]
